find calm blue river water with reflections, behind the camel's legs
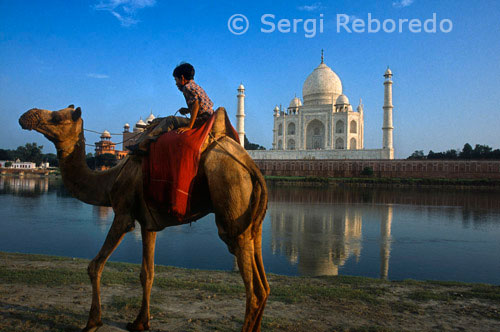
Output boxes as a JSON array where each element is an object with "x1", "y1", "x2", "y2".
[{"x1": 0, "y1": 177, "x2": 500, "y2": 285}]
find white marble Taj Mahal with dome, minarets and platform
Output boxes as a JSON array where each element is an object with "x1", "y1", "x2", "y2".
[{"x1": 246, "y1": 54, "x2": 394, "y2": 159}]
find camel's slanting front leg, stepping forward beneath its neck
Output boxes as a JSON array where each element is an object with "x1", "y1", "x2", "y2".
[{"x1": 82, "y1": 215, "x2": 134, "y2": 332}]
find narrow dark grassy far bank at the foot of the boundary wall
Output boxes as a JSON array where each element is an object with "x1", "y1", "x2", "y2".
[{"x1": 265, "y1": 175, "x2": 500, "y2": 191}]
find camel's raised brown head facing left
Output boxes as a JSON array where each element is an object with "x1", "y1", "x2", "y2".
[{"x1": 19, "y1": 105, "x2": 83, "y2": 158}]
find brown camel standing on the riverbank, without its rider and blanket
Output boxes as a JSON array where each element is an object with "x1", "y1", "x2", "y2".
[{"x1": 19, "y1": 105, "x2": 269, "y2": 332}]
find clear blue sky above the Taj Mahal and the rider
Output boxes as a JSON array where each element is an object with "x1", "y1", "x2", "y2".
[{"x1": 0, "y1": 0, "x2": 500, "y2": 158}]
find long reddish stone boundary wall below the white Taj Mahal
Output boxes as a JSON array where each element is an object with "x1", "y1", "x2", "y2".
[{"x1": 254, "y1": 159, "x2": 500, "y2": 179}]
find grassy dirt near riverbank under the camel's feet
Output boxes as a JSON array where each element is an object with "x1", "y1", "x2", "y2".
[{"x1": 0, "y1": 252, "x2": 500, "y2": 332}]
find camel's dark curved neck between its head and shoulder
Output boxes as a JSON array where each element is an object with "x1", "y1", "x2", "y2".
[{"x1": 58, "y1": 125, "x2": 121, "y2": 206}]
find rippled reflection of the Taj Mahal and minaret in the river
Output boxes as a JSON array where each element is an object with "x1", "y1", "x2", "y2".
[{"x1": 268, "y1": 190, "x2": 392, "y2": 279}]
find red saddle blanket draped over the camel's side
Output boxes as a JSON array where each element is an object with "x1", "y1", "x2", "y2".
[{"x1": 142, "y1": 114, "x2": 239, "y2": 222}]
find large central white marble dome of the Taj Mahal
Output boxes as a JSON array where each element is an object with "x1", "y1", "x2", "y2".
[{"x1": 302, "y1": 62, "x2": 342, "y2": 105}]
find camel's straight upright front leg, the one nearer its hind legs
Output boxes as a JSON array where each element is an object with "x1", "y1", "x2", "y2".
[{"x1": 127, "y1": 227, "x2": 156, "y2": 331}]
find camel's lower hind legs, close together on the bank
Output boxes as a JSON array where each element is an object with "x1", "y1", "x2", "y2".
[{"x1": 234, "y1": 227, "x2": 270, "y2": 332}]
